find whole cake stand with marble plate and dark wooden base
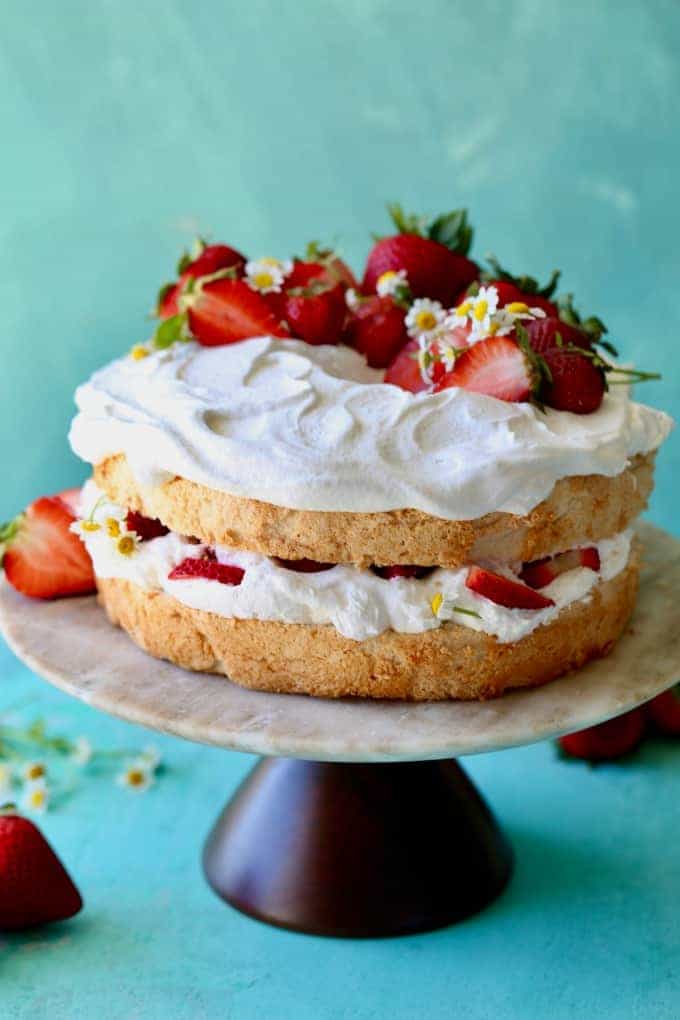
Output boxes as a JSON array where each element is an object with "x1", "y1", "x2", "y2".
[{"x1": 0, "y1": 524, "x2": 680, "y2": 936}]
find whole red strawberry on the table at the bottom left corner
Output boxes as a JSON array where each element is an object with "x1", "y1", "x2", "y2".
[{"x1": 0, "y1": 813, "x2": 83, "y2": 931}]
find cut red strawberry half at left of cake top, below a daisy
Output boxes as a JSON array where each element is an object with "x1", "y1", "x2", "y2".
[{"x1": 189, "y1": 278, "x2": 290, "y2": 347}]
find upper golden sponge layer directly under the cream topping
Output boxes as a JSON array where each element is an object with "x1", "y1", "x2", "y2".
[{"x1": 94, "y1": 453, "x2": 655, "y2": 567}]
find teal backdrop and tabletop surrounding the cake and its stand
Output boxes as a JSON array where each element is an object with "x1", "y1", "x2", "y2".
[{"x1": 0, "y1": 0, "x2": 680, "y2": 1020}]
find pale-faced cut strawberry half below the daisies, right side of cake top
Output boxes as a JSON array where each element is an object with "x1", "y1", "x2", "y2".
[{"x1": 434, "y1": 337, "x2": 536, "y2": 402}]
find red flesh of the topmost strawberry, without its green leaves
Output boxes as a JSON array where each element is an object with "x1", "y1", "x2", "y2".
[{"x1": 363, "y1": 234, "x2": 479, "y2": 306}]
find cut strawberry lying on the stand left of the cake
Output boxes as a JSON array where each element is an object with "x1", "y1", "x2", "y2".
[{"x1": 0, "y1": 496, "x2": 95, "y2": 599}]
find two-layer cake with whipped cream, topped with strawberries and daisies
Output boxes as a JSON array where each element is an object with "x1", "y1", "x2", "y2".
[{"x1": 5, "y1": 208, "x2": 672, "y2": 700}]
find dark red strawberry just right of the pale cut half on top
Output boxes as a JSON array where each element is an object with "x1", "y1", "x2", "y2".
[{"x1": 525, "y1": 318, "x2": 607, "y2": 414}]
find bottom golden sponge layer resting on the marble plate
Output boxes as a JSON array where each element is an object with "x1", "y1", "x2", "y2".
[{"x1": 98, "y1": 550, "x2": 638, "y2": 701}]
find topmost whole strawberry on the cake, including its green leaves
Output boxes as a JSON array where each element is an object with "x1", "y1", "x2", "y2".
[{"x1": 363, "y1": 205, "x2": 479, "y2": 305}]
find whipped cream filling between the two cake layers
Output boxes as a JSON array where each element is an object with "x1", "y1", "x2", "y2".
[{"x1": 82, "y1": 483, "x2": 632, "y2": 643}]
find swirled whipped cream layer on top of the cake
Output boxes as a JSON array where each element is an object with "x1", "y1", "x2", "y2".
[{"x1": 70, "y1": 337, "x2": 672, "y2": 520}]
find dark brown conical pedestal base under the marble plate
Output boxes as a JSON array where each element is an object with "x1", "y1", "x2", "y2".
[{"x1": 203, "y1": 758, "x2": 513, "y2": 937}]
